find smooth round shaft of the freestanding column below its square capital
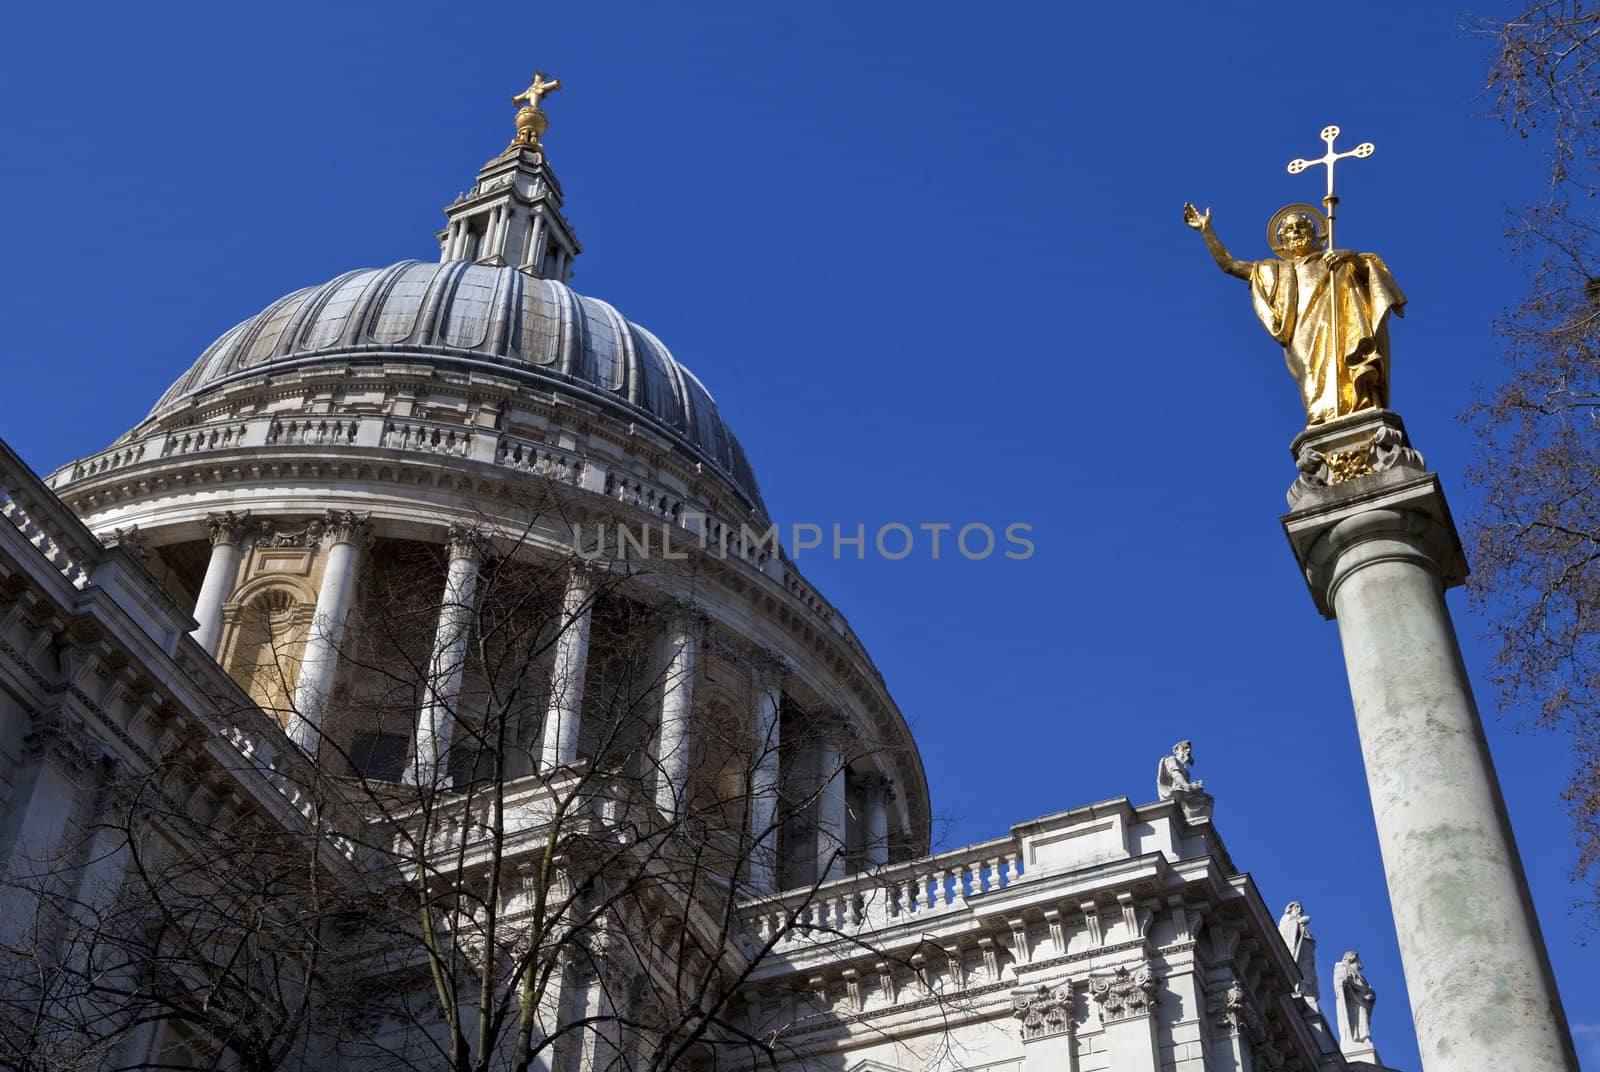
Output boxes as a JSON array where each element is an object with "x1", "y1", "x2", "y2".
[{"x1": 1330, "y1": 510, "x2": 1578, "y2": 1072}]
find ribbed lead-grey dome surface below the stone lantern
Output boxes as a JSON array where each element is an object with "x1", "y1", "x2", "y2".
[{"x1": 150, "y1": 261, "x2": 766, "y2": 515}]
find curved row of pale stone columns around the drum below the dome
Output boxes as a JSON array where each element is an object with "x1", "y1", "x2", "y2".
[{"x1": 190, "y1": 510, "x2": 894, "y2": 891}]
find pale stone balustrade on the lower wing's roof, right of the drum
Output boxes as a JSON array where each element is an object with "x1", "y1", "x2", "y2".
[{"x1": 741, "y1": 837, "x2": 1022, "y2": 946}]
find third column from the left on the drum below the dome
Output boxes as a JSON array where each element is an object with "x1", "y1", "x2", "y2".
[{"x1": 406, "y1": 525, "x2": 480, "y2": 786}]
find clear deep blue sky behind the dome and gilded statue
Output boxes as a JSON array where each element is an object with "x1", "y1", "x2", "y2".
[{"x1": 0, "y1": 3, "x2": 1600, "y2": 1069}]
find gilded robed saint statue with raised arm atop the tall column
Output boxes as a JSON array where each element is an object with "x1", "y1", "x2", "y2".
[{"x1": 1184, "y1": 205, "x2": 1405, "y2": 424}]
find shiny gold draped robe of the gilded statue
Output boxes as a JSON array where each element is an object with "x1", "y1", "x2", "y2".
[{"x1": 1250, "y1": 253, "x2": 1405, "y2": 424}]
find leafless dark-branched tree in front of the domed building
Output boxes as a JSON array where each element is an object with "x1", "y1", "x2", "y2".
[{"x1": 0, "y1": 470, "x2": 942, "y2": 1072}]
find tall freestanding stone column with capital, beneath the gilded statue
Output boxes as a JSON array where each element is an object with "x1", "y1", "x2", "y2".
[{"x1": 1283, "y1": 411, "x2": 1578, "y2": 1072}]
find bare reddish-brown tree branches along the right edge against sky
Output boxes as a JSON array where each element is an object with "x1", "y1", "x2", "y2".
[{"x1": 1467, "y1": 0, "x2": 1600, "y2": 907}]
